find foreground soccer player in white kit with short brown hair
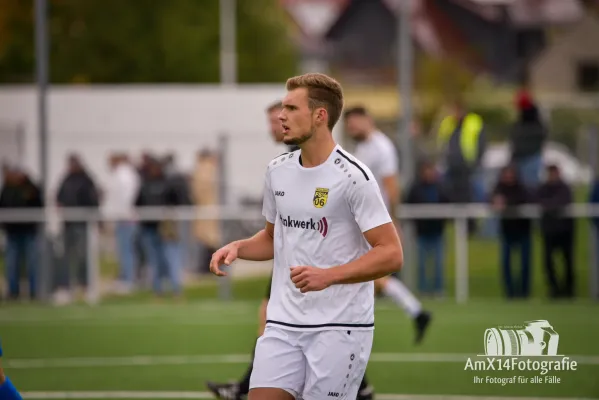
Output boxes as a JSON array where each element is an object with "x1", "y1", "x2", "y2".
[{"x1": 210, "y1": 74, "x2": 403, "y2": 400}]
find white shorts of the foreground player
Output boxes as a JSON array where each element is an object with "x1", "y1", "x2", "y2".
[{"x1": 250, "y1": 325, "x2": 374, "y2": 400}]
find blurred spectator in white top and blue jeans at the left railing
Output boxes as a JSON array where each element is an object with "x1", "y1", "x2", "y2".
[{"x1": 103, "y1": 154, "x2": 140, "y2": 293}]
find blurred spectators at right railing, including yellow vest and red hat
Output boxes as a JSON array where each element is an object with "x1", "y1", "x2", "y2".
[{"x1": 405, "y1": 89, "x2": 599, "y2": 298}]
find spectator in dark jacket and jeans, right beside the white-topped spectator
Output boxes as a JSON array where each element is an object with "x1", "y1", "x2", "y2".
[{"x1": 135, "y1": 159, "x2": 186, "y2": 295}]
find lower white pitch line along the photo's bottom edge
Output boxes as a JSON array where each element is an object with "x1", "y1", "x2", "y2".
[{"x1": 21, "y1": 391, "x2": 590, "y2": 400}]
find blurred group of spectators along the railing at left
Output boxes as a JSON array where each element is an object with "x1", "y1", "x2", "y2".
[{"x1": 0, "y1": 150, "x2": 220, "y2": 304}]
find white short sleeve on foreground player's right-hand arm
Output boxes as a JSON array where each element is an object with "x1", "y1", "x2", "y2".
[{"x1": 349, "y1": 180, "x2": 391, "y2": 232}]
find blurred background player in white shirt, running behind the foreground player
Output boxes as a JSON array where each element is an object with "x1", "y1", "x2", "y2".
[{"x1": 344, "y1": 107, "x2": 431, "y2": 344}]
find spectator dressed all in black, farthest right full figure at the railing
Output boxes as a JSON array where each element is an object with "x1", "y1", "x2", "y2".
[{"x1": 537, "y1": 165, "x2": 574, "y2": 298}]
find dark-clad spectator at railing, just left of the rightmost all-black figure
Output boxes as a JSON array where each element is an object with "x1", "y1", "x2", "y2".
[{"x1": 492, "y1": 165, "x2": 532, "y2": 298}]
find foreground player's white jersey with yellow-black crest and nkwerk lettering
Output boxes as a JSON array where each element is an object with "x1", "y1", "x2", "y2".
[{"x1": 263, "y1": 145, "x2": 391, "y2": 330}]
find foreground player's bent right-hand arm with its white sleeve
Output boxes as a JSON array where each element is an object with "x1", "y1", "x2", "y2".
[{"x1": 327, "y1": 180, "x2": 403, "y2": 285}]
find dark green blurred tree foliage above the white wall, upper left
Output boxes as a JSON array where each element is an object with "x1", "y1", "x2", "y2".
[{"x1": 0, "y1": 0, "x2": 297, "y2": 83}]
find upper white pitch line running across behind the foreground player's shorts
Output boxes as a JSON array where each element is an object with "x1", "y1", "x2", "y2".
[{"x1": 4, "y1": 353, "x2": 599, "y2": 369}]
